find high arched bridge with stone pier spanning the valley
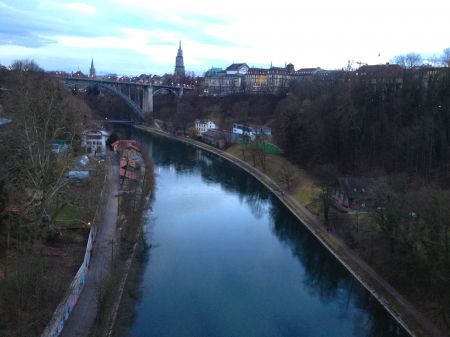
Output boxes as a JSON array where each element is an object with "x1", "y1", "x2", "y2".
[{"x1": 64, "y1": 77, "x2": 192, "y2": 119}]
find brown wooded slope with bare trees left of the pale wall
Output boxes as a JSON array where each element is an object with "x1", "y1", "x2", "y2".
[{"x1": 0, "y1": 61, "x2": 95, "y2": 336}]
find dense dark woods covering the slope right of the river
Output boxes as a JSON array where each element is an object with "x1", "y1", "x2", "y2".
[{"x1": 275, "y1": 68, "x2": 450, "y2": 178}]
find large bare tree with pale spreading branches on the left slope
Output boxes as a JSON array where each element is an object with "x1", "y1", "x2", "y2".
[{"x1": 1, "y1": 61, "x2": 88, "y2": 242}]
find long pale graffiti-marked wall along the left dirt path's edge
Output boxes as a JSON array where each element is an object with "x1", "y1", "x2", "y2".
[{"x1": 41, "y1": 174, "x2": 107, "y2": 337}]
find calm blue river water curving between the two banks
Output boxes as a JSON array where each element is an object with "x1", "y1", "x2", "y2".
[{"x1": 118, "y1": 133, "x2": 408, "y2": 337}]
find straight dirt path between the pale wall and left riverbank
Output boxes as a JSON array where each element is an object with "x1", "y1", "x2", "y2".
[{"x1": 60, "y1": 157, "x2": 119, "y2": 337}]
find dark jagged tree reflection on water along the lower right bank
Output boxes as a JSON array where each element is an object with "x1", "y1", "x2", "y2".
[{"x1": 270, "y1": 202, "x2": 409, "y2": 337}]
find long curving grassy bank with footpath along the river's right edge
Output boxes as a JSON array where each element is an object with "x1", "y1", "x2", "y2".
[{"x1": 137, "y1": 127, "x2": 443, "y2": 336}]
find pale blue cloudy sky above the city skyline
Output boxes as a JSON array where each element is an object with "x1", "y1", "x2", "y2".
[{"x1": 0, "y1": 0, "x2": 450, "y2": 75}]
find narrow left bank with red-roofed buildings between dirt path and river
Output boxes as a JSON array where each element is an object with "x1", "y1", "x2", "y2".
[{"x1": 89, "y1": 140, "x2": 154, "y2": 337}]
